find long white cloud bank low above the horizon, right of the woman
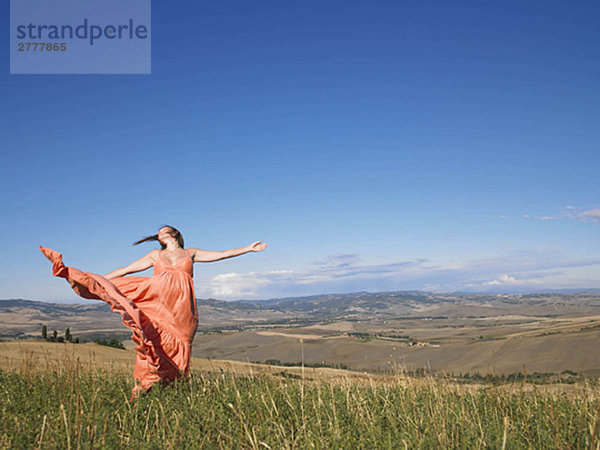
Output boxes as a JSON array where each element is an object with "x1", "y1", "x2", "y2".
[{"x1": 197, "y1": 249, "x2": 600, "y2": 300}]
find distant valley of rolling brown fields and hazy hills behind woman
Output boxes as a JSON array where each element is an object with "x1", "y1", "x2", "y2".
[{"x1": 0, "y1": 291, "x2": 600, "y2": 376}]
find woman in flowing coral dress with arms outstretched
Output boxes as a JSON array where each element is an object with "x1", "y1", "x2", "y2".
[{"x1": 40, "y1": 225, "x2": 267, "y2": 401}]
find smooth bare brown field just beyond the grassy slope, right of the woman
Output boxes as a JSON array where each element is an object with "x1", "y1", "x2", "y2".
[{"x1": 192, "y1": 329, "x2": 600, "y2": 376}]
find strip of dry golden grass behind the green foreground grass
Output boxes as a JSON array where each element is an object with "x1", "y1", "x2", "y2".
[{"x1": 0, "y1": 339, "x2": 595, "y2": 397}]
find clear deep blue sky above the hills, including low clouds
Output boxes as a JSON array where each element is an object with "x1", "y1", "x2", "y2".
[{"x1": 0, "y1": 1, "x2": 600, "y2": 301}]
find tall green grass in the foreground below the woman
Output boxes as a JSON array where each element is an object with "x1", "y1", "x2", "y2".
[{"x1": 0, "y1": 343, "x2": 600, "y2": 449}]
